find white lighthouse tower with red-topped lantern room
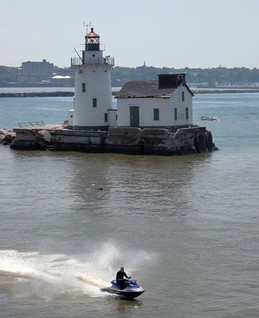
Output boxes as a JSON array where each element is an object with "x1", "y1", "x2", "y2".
[{"x1": 71, "y1": 28, "x2": 114, "y2": 130}]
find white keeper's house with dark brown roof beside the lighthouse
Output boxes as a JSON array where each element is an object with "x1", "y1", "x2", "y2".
[{"x1": 117, "y1": 74, "x2": 193, "y2": 128}]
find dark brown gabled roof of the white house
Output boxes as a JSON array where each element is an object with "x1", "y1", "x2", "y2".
[{"x1": 116, "y1": 81, "x2": 177, "y2": 98}]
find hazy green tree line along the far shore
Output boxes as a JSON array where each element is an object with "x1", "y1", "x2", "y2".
[{"x1": 0, "y1": 65, "x2": 259, "y2": 88}]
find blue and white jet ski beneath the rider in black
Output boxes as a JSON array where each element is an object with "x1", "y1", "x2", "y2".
[{"x1": 101, "y1": 278, "x2": 145, "y2": 299}]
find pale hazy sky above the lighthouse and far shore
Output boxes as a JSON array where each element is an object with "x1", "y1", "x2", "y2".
[{"x1": 0, "y1": 0, "x2": 259, "y2": 68}]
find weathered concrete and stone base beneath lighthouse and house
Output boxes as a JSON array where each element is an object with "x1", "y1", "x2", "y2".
[{"x1": 10, "y1": 125, "x2": 217, "y2": 156}]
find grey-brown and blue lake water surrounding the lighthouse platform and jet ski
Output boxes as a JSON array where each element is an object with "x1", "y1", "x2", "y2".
[{"x1": 0, "y1": 94, "x2": 259, "y2": 318}]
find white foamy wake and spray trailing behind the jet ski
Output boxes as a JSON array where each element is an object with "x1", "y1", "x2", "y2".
[{"x1": 0, "y1": 243, "x2": 156, "y2": 300}]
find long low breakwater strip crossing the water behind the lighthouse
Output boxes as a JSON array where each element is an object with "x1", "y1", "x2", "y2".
[{"x1": 0, "y1": 87, "x2": 259, "y2": 98}]
